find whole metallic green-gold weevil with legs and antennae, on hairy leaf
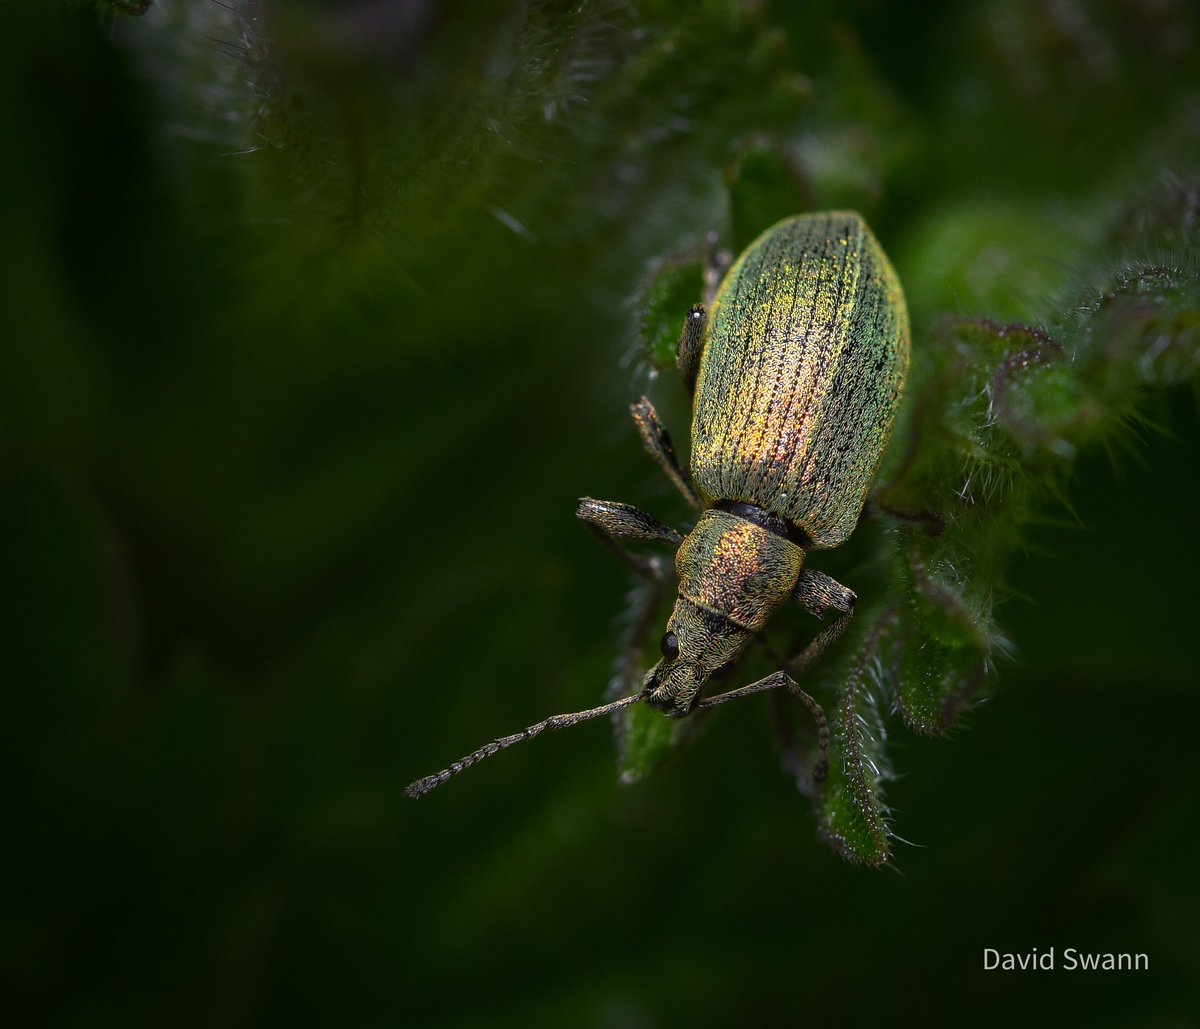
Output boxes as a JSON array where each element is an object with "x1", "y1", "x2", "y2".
[{"x1": 407, "y1": 211, "x2": 910, "y2": 796}]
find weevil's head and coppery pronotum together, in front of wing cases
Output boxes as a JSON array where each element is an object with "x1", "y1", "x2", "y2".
[{"x1": 642, "y1": 509, "x2": 804, "y2": 718}]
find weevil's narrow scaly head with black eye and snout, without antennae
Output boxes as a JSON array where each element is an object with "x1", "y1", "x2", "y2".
[{"x1": 642, "y1": 597, "x2": 752, "y2": 718}]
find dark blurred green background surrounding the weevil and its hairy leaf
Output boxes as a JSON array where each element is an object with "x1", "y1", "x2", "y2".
[{"x1": 0, "y1": 0, "x2": 1200, "y2": 1027}]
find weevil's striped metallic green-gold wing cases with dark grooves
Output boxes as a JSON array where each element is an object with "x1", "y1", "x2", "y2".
[{"x1": 691, "y1": 211, "x2": 910, "y2": 549}]
